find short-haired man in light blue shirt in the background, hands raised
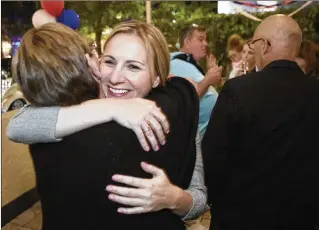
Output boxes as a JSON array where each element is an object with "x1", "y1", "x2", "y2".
[{"x1": 170, "y1": 25, "x2": 222, "y2": 137}]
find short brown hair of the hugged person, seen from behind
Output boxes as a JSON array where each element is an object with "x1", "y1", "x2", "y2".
[{"x1": 11, "y1": 23, "x2": 99, "y2": 106}]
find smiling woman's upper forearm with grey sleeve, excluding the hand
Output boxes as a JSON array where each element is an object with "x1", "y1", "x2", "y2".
[{"x1": 7, "y1": 99, "x2": 118, "y2": 144}]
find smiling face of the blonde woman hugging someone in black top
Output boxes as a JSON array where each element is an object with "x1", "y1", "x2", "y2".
[{"x1": 100, "y1": 33, "x2": 159, "y2": 98}]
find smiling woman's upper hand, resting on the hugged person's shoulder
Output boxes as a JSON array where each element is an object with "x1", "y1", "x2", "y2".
[{"x1": 113, "y1": 98, "x2": 169, "y2": 151}]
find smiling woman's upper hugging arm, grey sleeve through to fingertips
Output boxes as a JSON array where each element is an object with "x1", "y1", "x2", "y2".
[{"x1": 7, "y1": 98, "x2": 169, "y2": 151}]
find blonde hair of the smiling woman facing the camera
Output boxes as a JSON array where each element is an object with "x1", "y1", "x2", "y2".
[{"x1": 103, "y1": 20, "x2": 170, "y2": 85}]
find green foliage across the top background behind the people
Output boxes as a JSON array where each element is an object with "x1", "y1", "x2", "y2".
[{"x1": 73, "y1": 1, "x2": 319, "y2": 64}]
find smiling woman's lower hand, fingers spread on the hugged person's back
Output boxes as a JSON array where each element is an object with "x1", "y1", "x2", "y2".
[{"x1": 106, "y1": 162, "x2": 182, "y2": 214}]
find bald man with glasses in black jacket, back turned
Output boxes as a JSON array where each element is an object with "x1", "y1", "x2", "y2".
[{"x1": 202, "y1": 15, "x2": 319, "y2": 230}]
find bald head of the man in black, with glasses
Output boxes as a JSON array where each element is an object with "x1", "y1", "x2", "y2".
[{"x1": 254, "y1": 14, "x2": 302, "y2": 69}]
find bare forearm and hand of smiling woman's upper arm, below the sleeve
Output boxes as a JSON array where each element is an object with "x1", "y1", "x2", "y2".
[{"x1": 56, "y1": 98, "x2": 169, "y2": 151}]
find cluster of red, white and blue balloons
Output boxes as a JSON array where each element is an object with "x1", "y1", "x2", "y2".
[{"x1": 32, "y1": 0, "x2": 80, "y2": 30}]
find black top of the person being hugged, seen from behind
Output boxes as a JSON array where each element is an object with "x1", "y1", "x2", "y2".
[{"x1": 30, "y1": 78, "x2": 199, "y2": 230}]
